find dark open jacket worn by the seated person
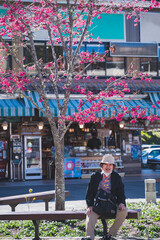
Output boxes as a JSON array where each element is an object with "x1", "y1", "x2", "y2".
[{"x1": 86, "y1": 171, "x2": 126, "y2": 207}]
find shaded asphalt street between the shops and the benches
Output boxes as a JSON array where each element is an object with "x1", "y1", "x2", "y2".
[{"x1": 0, "y1": 169, "x2": 160, "y2": 201}]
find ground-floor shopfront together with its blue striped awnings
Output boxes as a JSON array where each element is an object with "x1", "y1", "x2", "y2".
[{"x1": 0, "y1": 86, "x2": 160, "y2": 180}]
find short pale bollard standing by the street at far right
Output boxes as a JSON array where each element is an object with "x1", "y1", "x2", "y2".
[{"x1": 145, "y1": 179, "x2": 156, "y2": 203}]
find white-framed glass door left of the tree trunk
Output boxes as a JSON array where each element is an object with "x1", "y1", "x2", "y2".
[{"x1": 24, "y1": 136, "x2": 42, "y2": 179}]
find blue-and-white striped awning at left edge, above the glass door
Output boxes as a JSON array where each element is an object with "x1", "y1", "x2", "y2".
[{"x1": 0, "y1": 99, "x2": 34, "y2": 117}]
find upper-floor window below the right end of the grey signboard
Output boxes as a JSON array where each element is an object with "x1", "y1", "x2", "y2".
[{"x1": 140, "y1": 58, "x2": 160, "y2": 76}]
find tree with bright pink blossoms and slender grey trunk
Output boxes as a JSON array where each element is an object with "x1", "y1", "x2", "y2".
[{"x1": 0, "y1": 0, "x2": 159, "y2": 210}]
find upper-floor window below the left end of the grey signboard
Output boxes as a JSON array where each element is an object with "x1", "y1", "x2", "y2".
[{"x1": 106, "y1": 57, "x2": 125, "y2": 76}]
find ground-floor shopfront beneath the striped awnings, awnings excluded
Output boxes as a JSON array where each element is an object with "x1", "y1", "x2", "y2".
[{"x1": 0, "y1": 114, "x2": 160, "y2": 180}]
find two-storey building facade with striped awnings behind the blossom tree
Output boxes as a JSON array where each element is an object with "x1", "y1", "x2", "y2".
[{"x1": 0, "y1": 5, "x2": 160, "y2": 180}]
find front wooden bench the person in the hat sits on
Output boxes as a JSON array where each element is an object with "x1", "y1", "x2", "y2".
[{"x1": 0, "y1": 209, "x2": 141, "y2": 240}]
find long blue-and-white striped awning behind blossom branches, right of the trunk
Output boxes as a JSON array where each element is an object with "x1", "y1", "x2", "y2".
[{"x1": 24, "y1": 92, "x2": 160, "y2": 118}]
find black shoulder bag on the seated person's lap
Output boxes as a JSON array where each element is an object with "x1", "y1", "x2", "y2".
[{"x1": 93, "y1": 189, "x2": 117, "y2": 219}]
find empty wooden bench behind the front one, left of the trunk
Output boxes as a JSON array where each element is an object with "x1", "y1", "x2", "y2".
[{"x1": 0, "y1": 190, "x2": 69, "y2": 211}]
